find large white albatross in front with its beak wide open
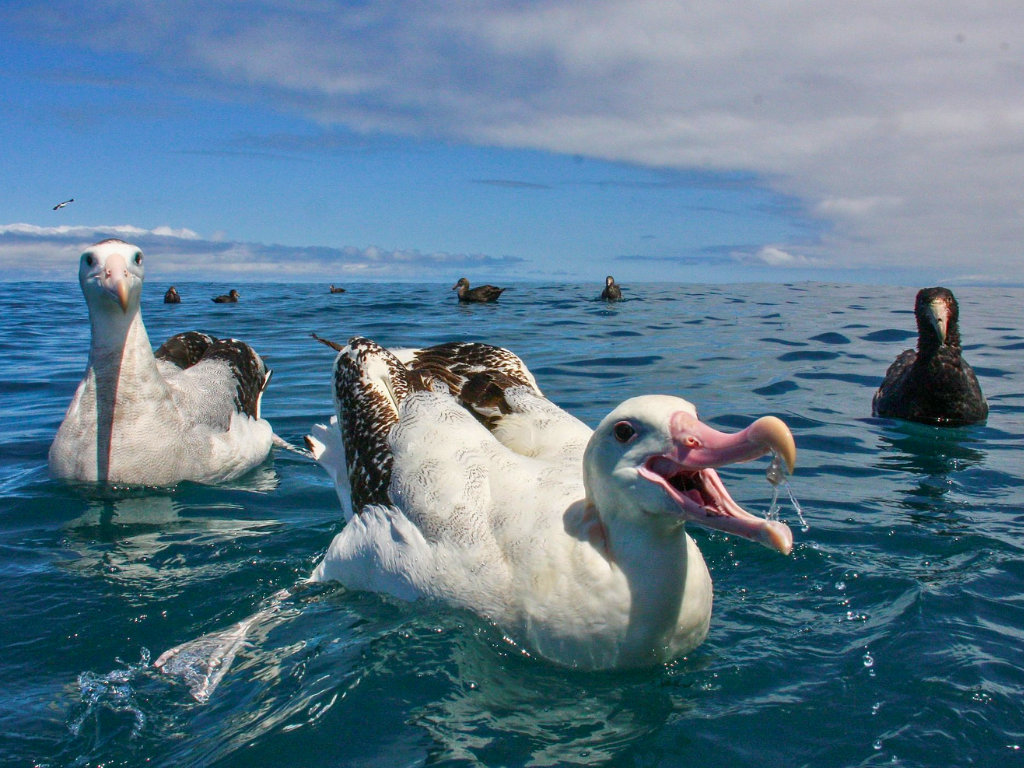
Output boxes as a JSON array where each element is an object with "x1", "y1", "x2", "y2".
[{"x1": 299, "y1": 338, "x2": 796, "y2": 670}]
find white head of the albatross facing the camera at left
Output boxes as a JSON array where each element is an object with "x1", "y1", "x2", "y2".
[{"x1": 78, "y1": 240, "x2": 145, "y2": 317}]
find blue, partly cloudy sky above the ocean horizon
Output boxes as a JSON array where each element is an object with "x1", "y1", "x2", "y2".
[{"x1": 0, "y1": 0, "x2": 1024, "y2": 286}]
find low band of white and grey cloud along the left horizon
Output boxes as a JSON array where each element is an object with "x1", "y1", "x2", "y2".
[{"x1": 0, "y1": 224, "x2": 523, "y2": 282}]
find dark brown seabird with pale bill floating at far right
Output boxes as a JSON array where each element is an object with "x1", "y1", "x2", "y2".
[{"x1": 871, "y1": 288, "x2": 988, "y2": 427}]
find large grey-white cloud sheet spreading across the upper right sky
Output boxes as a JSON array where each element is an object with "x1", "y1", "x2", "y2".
[{"x1": 12, "y1": 0, "x2": 1024, "y2": 269}]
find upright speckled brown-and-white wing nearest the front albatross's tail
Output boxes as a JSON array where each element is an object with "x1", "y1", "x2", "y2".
[{"x1": 334, "y1": 337, "x2": 423, "y2": 513}]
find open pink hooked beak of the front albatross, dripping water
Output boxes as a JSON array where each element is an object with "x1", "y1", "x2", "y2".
[{"x1": 639, "y1": 411, "x2": 797, "y2": 555}]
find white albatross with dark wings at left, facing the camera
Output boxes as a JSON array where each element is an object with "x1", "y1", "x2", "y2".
[{"x1": 49, "y1": 240, "x2": 273, "y2": 485}]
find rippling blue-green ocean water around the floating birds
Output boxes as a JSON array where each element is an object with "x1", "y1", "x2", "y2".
[{"x1": 0, "y1": 282, "x2": 1024, "y2": 768}]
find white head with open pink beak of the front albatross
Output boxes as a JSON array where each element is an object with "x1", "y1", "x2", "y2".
[{"x1": 584, "y1": 395, "x2": 797, "y2": 554}]
